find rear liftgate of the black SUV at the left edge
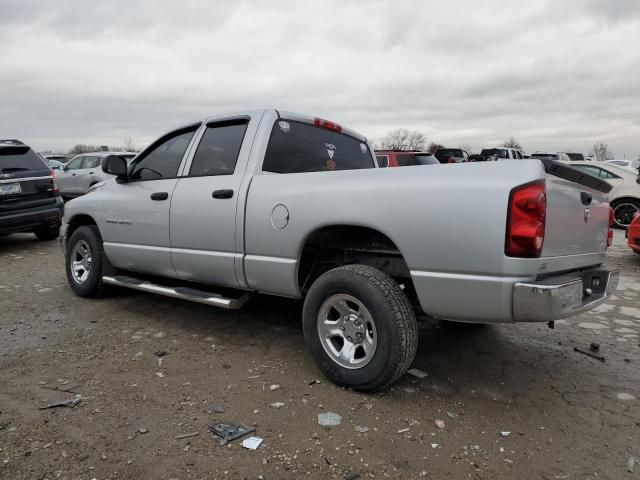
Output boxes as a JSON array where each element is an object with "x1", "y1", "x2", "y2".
[{"x1": 0, "y1": 145, "x2": 56, "y2": 215}]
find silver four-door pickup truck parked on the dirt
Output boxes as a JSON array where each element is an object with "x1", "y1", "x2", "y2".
[{"x1": 62, "y1": 110, "x2": 618, "y2": 391}]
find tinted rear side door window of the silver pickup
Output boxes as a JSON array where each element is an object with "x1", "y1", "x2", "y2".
[{"x1": 189, "y1": 120, "x2": 248, "y2": 176}]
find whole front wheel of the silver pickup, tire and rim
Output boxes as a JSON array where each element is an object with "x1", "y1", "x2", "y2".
[{"x1": 65, "y1": 225, "x2": 107, "y2": 297}]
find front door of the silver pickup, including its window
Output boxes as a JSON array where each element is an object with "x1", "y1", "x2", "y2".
[{"x1": 100, "y1": 125, "x2": 199, "y2": 277}]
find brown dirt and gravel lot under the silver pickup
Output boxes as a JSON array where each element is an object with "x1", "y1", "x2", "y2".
[{"x1": 0, "y1": 232, "x2": 640, "y2": 480}]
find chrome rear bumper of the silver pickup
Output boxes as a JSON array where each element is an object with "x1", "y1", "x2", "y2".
[{"x1": 513, "y1": 268, "x2": 620, "y2": 322}]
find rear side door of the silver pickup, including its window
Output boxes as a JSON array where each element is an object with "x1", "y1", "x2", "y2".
[{"x1": 171, "y1": 118, "x2": 252, "y2": 287}]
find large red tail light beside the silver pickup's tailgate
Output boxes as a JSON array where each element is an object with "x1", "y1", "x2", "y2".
[{"x1": 505, "y1": 182, "x2": 547, "y2": 258}]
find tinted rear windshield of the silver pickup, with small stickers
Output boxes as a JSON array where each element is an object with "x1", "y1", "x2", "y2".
[{"x1": 262, "y1": 120, "x2": 374, "y2": 173}]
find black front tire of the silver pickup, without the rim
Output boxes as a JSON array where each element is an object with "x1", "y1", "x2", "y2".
[{"x1": 64, "y1": 225, "x2": 108, "y2": 298}]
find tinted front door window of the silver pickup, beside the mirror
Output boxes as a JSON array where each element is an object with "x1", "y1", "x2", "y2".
[{"x1": 131, "y1": 127, "x2": 197, "y2": 180}]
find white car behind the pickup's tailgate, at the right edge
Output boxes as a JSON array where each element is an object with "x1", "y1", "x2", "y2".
[{"x1": 570, "y1": 161, "x2": 640, "y2": 228}]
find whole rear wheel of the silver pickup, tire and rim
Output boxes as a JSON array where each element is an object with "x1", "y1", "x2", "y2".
[{"x1": 302, "y1": 265, "x2": 418, "y2": 392}]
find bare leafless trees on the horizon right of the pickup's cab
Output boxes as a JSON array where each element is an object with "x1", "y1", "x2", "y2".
[{"x1": 374, "y1": 128, "x2": 624, "y2": 162}]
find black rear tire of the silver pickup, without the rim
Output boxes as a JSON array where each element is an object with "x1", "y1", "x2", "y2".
[{"x1": 302, "y1": 265, "x2": 418, "y2": 392}]
